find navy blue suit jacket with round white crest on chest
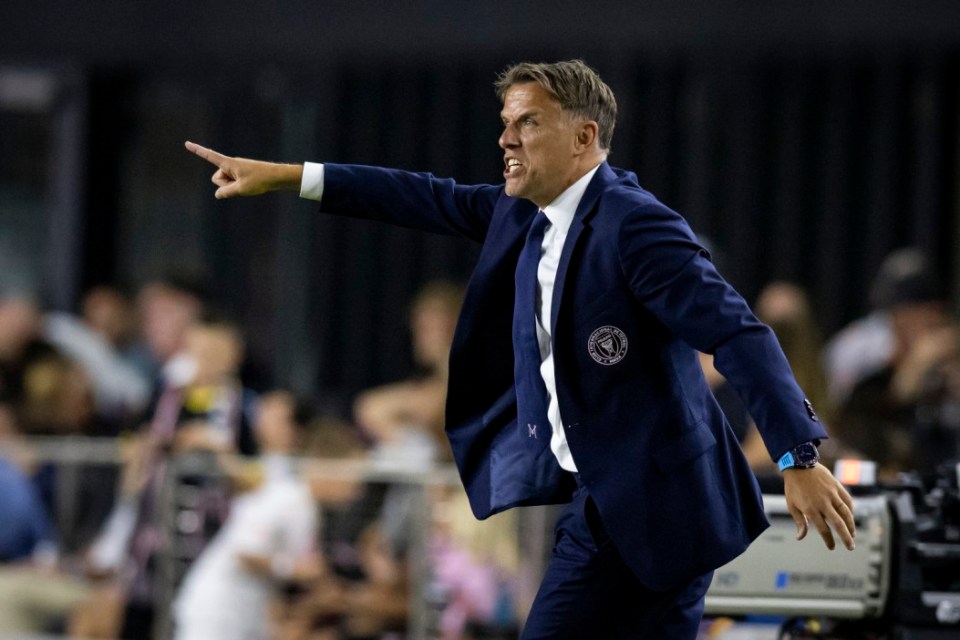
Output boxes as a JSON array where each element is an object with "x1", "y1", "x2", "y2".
[{"x1": 321, "y1": 163, "x2": 826, "y2": 589}]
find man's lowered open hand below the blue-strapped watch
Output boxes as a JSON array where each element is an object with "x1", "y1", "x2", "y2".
[{"x1": 783, "y1": 464, "x2": 856, "y2": 551}]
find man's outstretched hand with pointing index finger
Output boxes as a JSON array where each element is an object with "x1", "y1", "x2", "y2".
[{"x1": 185, "y1": 142, "x2": 303, "y2": 199}]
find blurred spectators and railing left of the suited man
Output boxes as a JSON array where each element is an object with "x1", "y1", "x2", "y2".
[{"x1": 0, "y1": 278, "x2": 549, "y2": 640}]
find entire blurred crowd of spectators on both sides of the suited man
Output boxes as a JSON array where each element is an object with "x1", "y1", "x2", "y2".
[{"x1": 0, "y1": 249, "x2": 960, "y2": 640}]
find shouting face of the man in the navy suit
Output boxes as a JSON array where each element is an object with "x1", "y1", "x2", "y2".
[{"x1": 499, "y1": 82, "x2": 580, "y2": 208}]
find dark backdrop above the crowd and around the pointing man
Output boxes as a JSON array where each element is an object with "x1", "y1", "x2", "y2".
[{"x1": 0, "y1": 0, "x2": 960, "y2": 404}]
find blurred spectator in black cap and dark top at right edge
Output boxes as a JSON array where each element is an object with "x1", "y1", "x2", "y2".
[{"x1": 837, "y1": 249, "x2": 960, "y2": 480}]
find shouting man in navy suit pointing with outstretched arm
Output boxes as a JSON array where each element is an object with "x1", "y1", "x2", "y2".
[{"x1": 187, "y1": 61, "x2": 855, "y2": 639}]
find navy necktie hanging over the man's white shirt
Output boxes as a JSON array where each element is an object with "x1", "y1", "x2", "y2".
[{"x1": 513, "y1": 211, "x2": 550, "y2": 445}]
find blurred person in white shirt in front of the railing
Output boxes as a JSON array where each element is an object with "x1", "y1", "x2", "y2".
[{"x1": 173, "y1": 392, "x2": 320, "y2": 640}]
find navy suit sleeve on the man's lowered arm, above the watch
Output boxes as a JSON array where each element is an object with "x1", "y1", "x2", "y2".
[{"x1": 620, "y1": 203, "x2": 827, "y2": 459}]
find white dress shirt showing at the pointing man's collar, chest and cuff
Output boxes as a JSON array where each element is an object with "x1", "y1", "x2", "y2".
[{"x1": 300, "y1": 162, "x2": 600, "y2": 472}]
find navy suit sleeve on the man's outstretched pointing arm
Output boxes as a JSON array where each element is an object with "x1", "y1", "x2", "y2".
[{"x1": 320, "y1": 163, "x2": 503, "y2": 242}]
